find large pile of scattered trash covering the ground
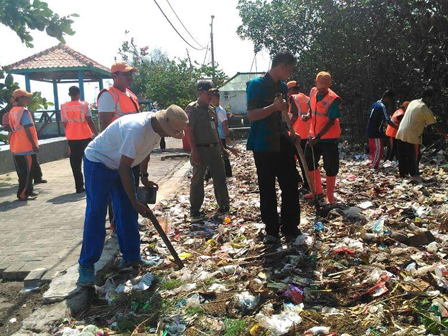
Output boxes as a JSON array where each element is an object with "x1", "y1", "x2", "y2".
[{"x1": 60, "y1": 144, "x2": 448, "y2": 336}]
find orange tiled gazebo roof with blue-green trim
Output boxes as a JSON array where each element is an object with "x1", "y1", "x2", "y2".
[{"x1": 6, "y1": 44, "x2": 111, "y2": 82}]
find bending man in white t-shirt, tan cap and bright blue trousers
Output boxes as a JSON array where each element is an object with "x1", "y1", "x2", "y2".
[{"x1": 78, "y1": 105, "x2": 188, "y2": 286}]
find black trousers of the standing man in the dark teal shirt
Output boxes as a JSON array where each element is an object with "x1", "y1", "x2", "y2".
[{"x1": 254, "y1": 139, "x2": 300, "y2": 237}]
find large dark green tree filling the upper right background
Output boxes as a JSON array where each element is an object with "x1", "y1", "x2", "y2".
[{"x1": 238, "y1": 0, "x2": 448, "y2": 138}]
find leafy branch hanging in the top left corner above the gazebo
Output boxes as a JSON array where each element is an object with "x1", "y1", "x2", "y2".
[{"x1": 0, "y1": 0, "x2": 78, "y2": 47}]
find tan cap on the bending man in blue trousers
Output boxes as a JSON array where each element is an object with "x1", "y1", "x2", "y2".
[{"x1": 156, "y1": 105, "x2": 188, "y2": 139}]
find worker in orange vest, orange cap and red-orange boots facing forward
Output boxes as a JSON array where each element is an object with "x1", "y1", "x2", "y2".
[{"x1": 303, "y1": 71, "x2": 342, "y2": 204}]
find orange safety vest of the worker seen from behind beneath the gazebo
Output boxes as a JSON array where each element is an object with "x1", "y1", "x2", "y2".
[{"x1": 61, "y1": 101, "x2": 92, "y2": 140}]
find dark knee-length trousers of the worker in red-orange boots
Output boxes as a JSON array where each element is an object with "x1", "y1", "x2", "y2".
[{"x1": 305, "y1": 141, "x2": 339, "y2": 176}]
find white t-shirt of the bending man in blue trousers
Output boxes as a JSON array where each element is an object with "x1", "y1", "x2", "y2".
[{"x1": 85, "y1": 112, "x2": 161, "y2": 170}]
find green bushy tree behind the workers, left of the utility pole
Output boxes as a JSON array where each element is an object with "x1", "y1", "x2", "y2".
[{"x1": 119, "y1": 39, "x2": 225, "y2": 107}]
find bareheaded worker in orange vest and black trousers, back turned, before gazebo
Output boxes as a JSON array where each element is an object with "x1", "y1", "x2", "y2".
[{"x1": 61, "y1": 86, "x2": 98, "y2": 194}]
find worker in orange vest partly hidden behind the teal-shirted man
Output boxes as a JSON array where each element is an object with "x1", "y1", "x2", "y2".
[{"x1": 286, "y1": 81, "x2": 310, "y2": 190}]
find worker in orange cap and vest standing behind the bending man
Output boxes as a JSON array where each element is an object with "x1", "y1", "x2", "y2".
[{"x1": 97, "y1": 62, "x2": 140, "y2": 231}]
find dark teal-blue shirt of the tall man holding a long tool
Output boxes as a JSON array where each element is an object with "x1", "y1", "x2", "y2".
[{"x1": 246, "y1": 73, "x2": 287, "y2": 152}]
